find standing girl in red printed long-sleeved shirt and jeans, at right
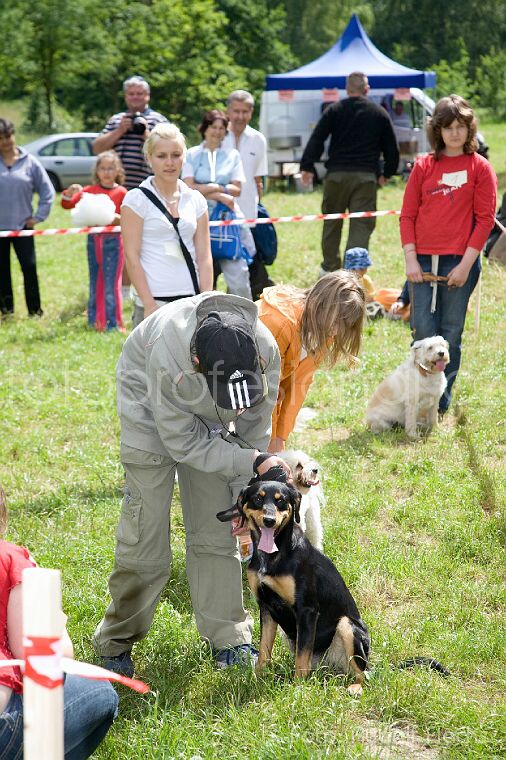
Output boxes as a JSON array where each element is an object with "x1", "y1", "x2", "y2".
[{"x1": 401, "y1": 95, "x2": 497, "y2": 414}]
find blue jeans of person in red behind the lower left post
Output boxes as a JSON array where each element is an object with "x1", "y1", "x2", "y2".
[{"x1": 0, "y1": 676, "x2": 118, "y2": 760}]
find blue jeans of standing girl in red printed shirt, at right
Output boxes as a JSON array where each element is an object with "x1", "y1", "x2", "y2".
[{"x1": 410, "y1": 256, "x2": 481, "y2": 412}]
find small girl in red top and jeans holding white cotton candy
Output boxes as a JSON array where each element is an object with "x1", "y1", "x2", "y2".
[{"x1": 61, "y1": 150, "x2": 127, "y2": 331}]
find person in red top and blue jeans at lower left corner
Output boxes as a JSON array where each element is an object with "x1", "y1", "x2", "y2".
[{"x1": 0, "y1": 489, "x2": 118, "y2": 760}]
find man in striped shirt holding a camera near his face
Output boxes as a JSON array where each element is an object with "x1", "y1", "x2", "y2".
[{"x1": 93, "y1": 76, "x2": 167, "y2": 190}]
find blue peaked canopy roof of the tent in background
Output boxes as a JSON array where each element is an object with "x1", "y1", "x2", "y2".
[{"x1": 265, "y1": 14, "x2": 436, "y2": 90}]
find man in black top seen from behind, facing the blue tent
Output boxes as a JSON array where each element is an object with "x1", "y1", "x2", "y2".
[{"x1": 300, "y1": 71, "x2": 399, "y2": 276}]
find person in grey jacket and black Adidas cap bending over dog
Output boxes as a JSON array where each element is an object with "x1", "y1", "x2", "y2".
[{"x1": 94, "y1": 293, "x2": 286, "y2": 675}]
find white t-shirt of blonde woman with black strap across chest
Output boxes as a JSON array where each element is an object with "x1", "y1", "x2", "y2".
[{"x1": 122, "y1": 177, "x2": 207, "y2": 298}]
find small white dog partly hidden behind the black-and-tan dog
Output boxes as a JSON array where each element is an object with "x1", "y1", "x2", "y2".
[{"x1": 277, "y1": 449, "x2": 325, "y2": 551}]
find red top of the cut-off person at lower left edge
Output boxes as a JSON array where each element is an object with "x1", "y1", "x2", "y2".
[{"x1": 0, "y1": 540, "x2": 37, "y2": 694}]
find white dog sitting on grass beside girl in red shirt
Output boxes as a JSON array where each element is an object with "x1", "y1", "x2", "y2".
[{"x1": 366, "y1": 335, "x2": 450, "y2": 438}]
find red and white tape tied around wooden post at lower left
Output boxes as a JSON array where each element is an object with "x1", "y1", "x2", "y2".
[{"x1": 0, "y1": 636, "x2": 150, "y2": 694}]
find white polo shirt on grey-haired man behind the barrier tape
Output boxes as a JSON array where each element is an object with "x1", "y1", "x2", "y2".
[{"x1": 221, "y1": 125, "x2": 268, "y2": 219}]
